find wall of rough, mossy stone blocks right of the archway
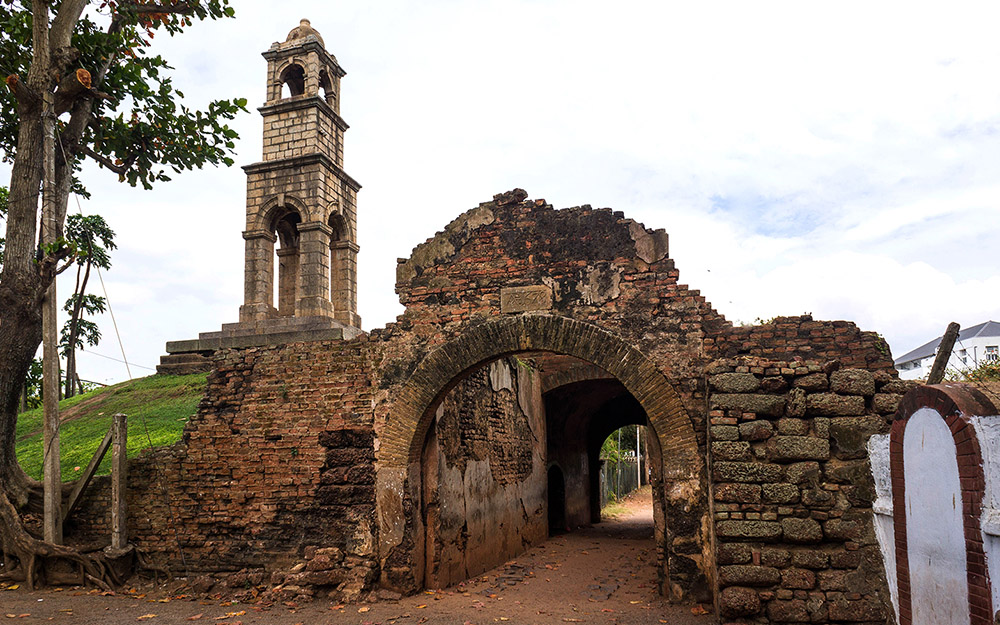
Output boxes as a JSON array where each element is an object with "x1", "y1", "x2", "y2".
[{"x1": 708, "y1": 357, "x2": 907, "y2": 623}]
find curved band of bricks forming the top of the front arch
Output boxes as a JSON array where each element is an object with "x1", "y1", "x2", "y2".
[{"x1": 380, "y1": 314, "x2": 699, "y2": 479}]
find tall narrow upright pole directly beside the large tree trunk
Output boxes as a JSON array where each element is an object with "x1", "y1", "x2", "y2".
[{"x1": 42, "y1": 91, "x2": 62, "y2": 545}]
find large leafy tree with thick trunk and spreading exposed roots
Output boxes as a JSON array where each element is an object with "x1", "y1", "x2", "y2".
[{"x1": 0, "y1": 0, "x2": 246, "y2": 587}]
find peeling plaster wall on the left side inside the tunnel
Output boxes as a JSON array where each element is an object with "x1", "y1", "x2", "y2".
[{"x1": 422, "y1": 358, "x2": 548, "y2": 588}]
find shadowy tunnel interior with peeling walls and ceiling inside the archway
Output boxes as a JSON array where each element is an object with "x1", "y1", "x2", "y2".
[{"x1": 421, "y1": 352, "x2": 656, "y2": 588}]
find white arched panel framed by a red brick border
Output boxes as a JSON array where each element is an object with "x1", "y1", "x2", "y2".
[{"x1": 903, "y1": 408, "x2": 969, "y2": 625}]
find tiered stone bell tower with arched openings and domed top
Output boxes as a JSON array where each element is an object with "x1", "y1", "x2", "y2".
[{"x1": 240, "y1": 20, "x2": 361, "y2": 328}]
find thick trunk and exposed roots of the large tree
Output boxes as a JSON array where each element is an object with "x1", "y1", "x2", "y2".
[{"x1": 0, "y1": 0, "x2": 102, "y2": 587}]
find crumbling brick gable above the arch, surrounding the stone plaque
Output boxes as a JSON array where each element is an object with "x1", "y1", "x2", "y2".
[{"x1": 373, "y1": 192, "x2": 731, "y2": 436}]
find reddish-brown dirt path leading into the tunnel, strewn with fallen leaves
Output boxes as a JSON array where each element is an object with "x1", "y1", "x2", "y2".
[{"x1": 0, "y1": 489, "x2": 716, "y2": 625}]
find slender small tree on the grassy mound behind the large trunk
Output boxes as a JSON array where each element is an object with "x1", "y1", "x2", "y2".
[{"x1": 59, "y1": 215, "x2": 116, "y2": 397}]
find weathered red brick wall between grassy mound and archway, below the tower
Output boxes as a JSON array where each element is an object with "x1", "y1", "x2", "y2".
[{"x1": 70, "y1": 339, "x2": 376, "y2": 590}]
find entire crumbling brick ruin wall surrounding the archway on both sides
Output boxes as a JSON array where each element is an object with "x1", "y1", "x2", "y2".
[{"x1": 66, "y1": 194, "x2": 898, "y2": 621}]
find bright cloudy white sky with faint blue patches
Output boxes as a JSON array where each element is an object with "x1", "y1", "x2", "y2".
[{"x1": 2, "y1": 0, "x2": 1000, "y2": 382}]
